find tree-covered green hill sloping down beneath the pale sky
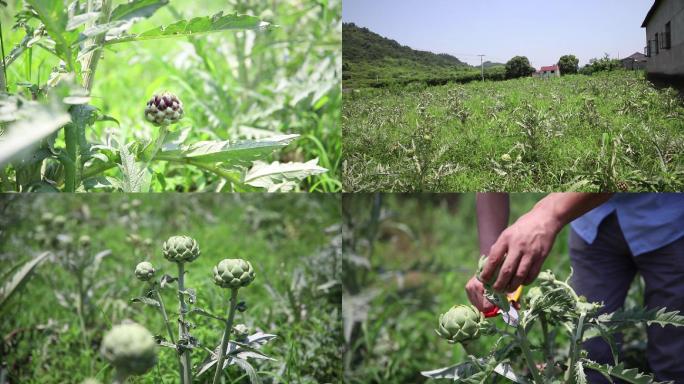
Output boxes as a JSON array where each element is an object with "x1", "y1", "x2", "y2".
[{"x1": 342, "y1": 23, "x2": 504, "y2": 88}]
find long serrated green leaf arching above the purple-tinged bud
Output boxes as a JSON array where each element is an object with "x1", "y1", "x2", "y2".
[{"x1": 105, "y1": 12, "x2": 271, "y2": 45}]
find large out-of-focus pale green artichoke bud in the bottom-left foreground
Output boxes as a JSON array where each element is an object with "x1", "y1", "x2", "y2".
[{"x1": 100, "y1": 323, "x2": 157, "y2": 376}]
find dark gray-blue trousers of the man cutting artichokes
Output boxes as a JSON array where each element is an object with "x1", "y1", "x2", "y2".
[{"x1": 570, "y1": 213, "x2": 684, "y2": 384}]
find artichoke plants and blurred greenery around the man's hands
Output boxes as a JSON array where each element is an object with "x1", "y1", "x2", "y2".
[{"x1": 342, "y1": 194, "x2": 684, "y2": 384}]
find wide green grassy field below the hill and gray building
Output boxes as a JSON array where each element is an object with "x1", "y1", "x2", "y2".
[{"x1": 342, "y1": 71, "x2": 684, "y2": 192}]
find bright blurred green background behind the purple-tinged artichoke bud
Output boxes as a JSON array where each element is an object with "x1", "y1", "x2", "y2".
[{"x1": 0, "y1": 0, "x2": 342, "y2": 192}]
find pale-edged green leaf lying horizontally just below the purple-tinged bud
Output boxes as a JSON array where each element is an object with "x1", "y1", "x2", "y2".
[{"x1": 156, "y1": 135, "x2": 299, "y2": 164}]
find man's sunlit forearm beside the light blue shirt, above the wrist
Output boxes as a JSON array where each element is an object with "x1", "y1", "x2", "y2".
[{"x1": 533, "y1": 192, "x2": 613, "y2": 231}]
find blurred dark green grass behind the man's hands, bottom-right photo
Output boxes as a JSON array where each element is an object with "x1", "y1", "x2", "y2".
[{"x1": 343, "y1": 194, "x2": 646, "y2": 383}]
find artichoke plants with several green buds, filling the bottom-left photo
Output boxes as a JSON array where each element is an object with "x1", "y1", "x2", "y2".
[{"x1": 0, "y1": 194, "x2": 343, "y2": 384}]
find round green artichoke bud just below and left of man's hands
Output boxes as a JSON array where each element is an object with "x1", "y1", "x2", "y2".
[{"x1": 436, "y1": 305, "x2": 485, "y2": 343}]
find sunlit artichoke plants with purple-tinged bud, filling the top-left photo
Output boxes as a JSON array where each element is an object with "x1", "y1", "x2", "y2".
[{"x1": 0, "y1": 0, "x2": 342, "y2": 192}]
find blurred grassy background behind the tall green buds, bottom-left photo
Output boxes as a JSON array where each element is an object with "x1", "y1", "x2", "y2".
[{"x1": 0, "y1": 194, "x2": 342, "y2": 384}]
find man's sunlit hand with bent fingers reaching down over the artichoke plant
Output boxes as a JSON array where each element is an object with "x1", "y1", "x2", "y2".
[{"x1": 481, "y1": 201, "x2": 564, "y2": 292}]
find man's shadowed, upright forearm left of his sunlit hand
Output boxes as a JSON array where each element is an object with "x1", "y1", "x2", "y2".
[{"x1": 475, "y1": 192, "x2": 510, "y2": 255}]
